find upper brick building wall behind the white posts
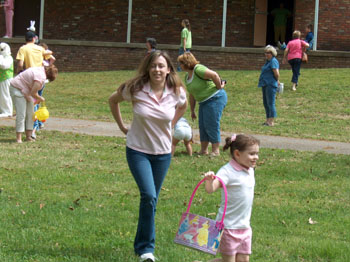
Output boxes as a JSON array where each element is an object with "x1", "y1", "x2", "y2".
[{"x1": 0, "y1": 0, "x2": 350, "y2": 51}]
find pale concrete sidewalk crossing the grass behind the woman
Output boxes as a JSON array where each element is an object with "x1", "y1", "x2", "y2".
[{"x1": 0, "y1": 117, "x2": 350, "y2": 155}]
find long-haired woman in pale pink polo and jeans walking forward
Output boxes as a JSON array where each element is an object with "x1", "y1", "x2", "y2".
[{"x1": 109, "y1": 50, "x2": 187, "y2": 261}]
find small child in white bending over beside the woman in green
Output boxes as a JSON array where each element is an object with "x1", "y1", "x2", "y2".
[{"x1": 171, "y1": 117, "x2": 192, "y2": 156}]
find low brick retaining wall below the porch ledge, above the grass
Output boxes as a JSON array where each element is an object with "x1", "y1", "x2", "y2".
[{"x1": 5, "y1": 40, "x2": 350, "y2": 72}]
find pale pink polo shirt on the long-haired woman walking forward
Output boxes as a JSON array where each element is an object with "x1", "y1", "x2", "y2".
[{"x1": 122, "y1": 83, "x2": 186, "y2": 155}]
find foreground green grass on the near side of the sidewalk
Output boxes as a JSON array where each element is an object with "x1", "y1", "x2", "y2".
[{"x1": 0, "y1": 127, "x2": 350, "y2": 262}]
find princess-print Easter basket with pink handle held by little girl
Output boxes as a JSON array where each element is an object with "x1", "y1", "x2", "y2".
[{"x1": 174, "y1": 176, "x2": 227, "y2": 255}]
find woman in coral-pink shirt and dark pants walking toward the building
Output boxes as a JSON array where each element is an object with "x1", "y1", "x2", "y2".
[{"x1": 282, "y1": 30, "x2": 309, "y2": 91}]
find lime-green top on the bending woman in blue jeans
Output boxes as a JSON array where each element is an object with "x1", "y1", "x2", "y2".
[{"x1": 185, "y1": 64, "x2": 218, "y2": 102}]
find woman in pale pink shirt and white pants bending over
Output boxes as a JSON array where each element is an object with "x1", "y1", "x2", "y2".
[{"x1": 10, "y1": 65, "x2": 58, "y2": 143}]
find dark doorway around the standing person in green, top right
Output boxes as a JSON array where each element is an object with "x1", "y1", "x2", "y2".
[{"x1": 266, "y1": 0, "x2": 294, "y2": 46}]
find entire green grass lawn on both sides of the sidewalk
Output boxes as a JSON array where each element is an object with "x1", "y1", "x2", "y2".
[{"x1": 0, "y1": 69, "x2": 350, "y2": 262}]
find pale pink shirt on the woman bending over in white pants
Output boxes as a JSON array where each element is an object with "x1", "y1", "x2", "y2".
[{"x1": 11, "y1": 66, "x2": 46, "y2": 100}]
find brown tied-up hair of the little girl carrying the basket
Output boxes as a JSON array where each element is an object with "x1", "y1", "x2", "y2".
[{"x1": 223, "y1": 134, "x2": 260, "y2": 158}]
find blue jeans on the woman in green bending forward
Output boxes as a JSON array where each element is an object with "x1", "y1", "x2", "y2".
[{"x1": 198, "y1": 89, "x2": 227, "y2": 144}]
